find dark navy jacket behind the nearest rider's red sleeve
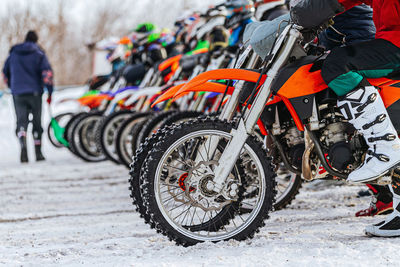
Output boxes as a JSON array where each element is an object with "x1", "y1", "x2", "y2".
[{"x1": 319, "y1": 5, "x2": 376, "y2": 50}]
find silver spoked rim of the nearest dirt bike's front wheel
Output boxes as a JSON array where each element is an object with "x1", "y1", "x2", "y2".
[{"x1": 150, "y1": 126, "x2": 268, "y2": 241}]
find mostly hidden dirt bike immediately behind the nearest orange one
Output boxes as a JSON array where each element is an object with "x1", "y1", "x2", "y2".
[{"x1": 130, "y1": 47, "x2": 294, "y2": 231}]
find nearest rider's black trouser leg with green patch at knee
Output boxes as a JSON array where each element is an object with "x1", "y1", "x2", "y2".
[{"x1": 321, "y1": 39, "x2": 400, "y2": 96}]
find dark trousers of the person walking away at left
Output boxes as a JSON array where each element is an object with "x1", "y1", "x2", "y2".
[{"x1": 13, "y1": 94, "x2": 43, "y2": 140}]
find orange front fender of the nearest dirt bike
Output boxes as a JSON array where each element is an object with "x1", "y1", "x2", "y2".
[{"x1": 175, "y1": 69, "x2": 266, "y2": 96}]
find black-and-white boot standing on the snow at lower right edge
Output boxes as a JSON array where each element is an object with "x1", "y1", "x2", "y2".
[{"x1": 365, "y1": 172, "x2": 400, "y2": 237}]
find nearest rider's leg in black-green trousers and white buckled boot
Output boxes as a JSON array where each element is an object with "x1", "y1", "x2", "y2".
[{"x1": 321, "y1": 39, "x2": 400, "y2": 182}]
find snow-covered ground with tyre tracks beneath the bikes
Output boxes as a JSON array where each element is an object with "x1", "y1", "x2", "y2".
[{"x1": 0, "y1": 89, "x2": 400, "y2": 266}]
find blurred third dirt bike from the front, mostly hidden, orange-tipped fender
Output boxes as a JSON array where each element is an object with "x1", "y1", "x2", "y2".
[{"x1": 115, "y1": 8, "x2": 244, "y2": 169}]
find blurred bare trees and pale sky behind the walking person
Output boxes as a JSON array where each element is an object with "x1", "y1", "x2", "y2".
[{"x1": 0, "y1": 0, "x2": 220, "y2": 85}]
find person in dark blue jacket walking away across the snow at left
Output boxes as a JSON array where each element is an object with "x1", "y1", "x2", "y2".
[{"x1": 3, "y1": 31, "x2": 53, "y2": 163}]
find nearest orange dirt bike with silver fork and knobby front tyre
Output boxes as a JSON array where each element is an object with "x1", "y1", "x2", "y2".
[{"x1": 136, "y1": 18, "x2": 400, "y2": 246}]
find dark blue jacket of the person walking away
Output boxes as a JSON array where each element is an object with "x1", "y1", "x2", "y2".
[{"x1": 3, "y1": 42, "x2": 53, "y2": 95}]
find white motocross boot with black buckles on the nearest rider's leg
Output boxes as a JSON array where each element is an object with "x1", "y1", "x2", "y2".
[{"x1": 338, "y1": 86, "x2": 400, "y2": 183}]
